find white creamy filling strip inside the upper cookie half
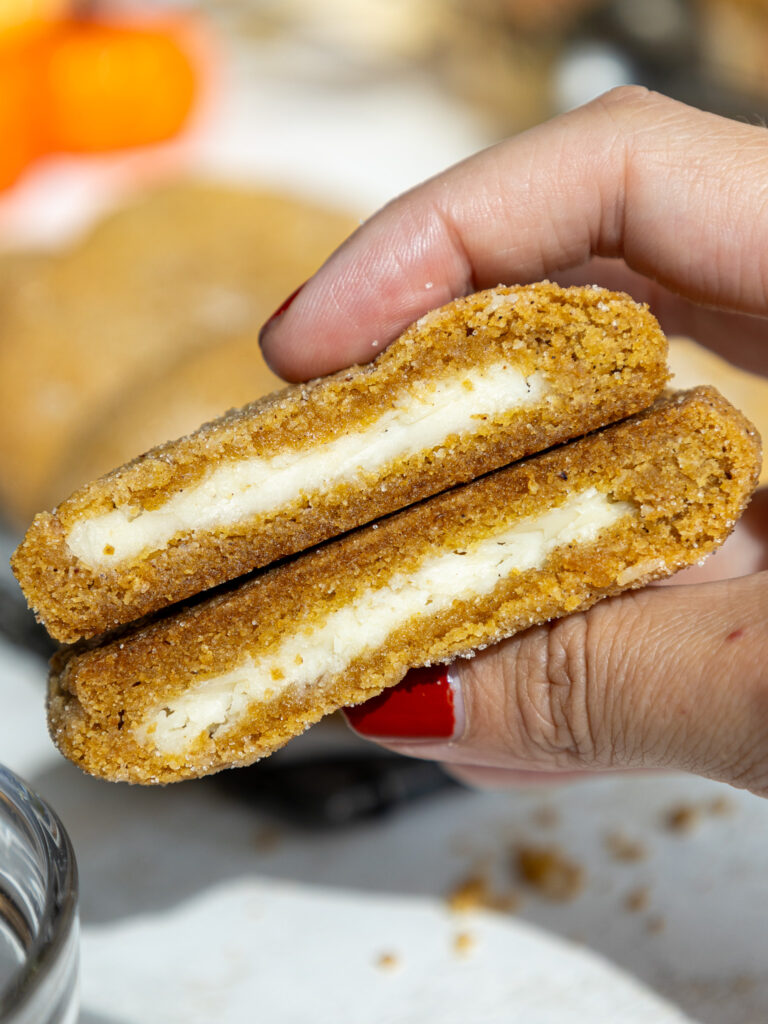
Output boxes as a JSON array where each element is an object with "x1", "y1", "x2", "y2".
[{"x1": 67, "y1": 362, "x2": 546, "y2": 570}]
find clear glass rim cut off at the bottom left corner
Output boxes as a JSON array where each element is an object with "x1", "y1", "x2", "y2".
[{"x1": 0, "y1": 765, "x2": 79, "y2": 1024}]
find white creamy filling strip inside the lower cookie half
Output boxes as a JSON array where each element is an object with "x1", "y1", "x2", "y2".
[{"x1": 135, "y1": 487, "x2": 634, "y2": 754}]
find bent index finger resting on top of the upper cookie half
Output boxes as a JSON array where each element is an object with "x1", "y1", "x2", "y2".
[{"x1": 262, "y1": 86, "x2": 768, "y2": 380}]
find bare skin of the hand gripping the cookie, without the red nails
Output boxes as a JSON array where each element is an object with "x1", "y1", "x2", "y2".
[{"x1": 262, "y1": 87, "x2": 768, "y2": 794}]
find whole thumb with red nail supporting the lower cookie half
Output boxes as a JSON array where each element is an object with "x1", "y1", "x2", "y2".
[{"x1": 347, "y1": 573, "x2": 768, "y2": 795}]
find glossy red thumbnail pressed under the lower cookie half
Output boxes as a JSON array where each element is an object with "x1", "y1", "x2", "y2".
[{"x1": 344, "y1": 665, "x2": 464, "y2": 742}]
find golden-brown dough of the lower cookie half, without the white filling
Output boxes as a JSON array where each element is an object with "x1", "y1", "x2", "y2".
[{"x1": 48, "y1": 388, "x2": 761, "y2": 783}]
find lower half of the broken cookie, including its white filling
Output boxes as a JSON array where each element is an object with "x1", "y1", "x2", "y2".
[{"x1": 49, "y1": 388, "x2": 761, "y2": 782}]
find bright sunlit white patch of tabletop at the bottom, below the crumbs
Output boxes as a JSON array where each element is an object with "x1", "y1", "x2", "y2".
[{"x1": 83, "y1": 879, "x2": 686, "y2": 1024}]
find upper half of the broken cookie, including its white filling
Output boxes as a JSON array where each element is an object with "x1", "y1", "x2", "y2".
[{"x1": 13, "y1": 283, "x2": 668, "y2": 642}]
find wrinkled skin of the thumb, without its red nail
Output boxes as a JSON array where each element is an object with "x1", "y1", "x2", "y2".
[{"x1": 469, "y1": 584, "x2": 768, "y2": 796}]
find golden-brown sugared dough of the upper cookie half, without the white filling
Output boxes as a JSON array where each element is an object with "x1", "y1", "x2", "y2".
[{"x1": 12, "y1": 282, "x2": 668, "y2": 642}]
